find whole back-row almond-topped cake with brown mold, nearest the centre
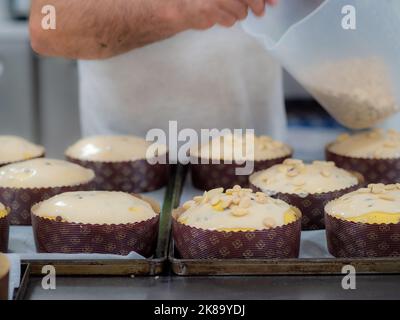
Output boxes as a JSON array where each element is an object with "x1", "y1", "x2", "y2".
[{"x1": 190, "y1": 135, "x2": 293, "y2": 190}]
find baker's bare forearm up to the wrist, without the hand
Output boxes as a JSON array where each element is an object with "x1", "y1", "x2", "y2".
[{"x1": 30, "y1": 0, "x2": 185, "y2": 59}]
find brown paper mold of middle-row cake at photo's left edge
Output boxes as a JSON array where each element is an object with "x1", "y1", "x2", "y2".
[{"x1": 0, "y1": 181, "x2": 93, "y2": 225}]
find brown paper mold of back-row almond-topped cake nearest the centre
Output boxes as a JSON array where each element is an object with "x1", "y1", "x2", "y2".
[{"x1": 190, "y1": 154, "x2": 292, "y2": 190}]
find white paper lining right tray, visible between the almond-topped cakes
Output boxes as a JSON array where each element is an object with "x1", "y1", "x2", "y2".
[{"x1": 180, "y1": 174, "x2": 334, "y2": 259}]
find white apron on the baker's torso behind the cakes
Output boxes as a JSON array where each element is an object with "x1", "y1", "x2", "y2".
[{"x1": 79, "y1": 25, "x2": 286, "y2": 139}]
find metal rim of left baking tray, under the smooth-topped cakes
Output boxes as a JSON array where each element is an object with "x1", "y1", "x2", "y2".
[{"x1": 10, "y1": 166, "x2": 177, "y2": 276}]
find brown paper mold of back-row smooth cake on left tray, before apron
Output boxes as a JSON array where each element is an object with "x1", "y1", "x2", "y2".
[{"x1": 66, "y1": 156, "x2": 169, "y2": 193}]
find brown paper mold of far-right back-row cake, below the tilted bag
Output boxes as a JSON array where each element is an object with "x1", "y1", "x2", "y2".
[{"x1": 325, "y1": 146, "x2": 400, "y2": 184}]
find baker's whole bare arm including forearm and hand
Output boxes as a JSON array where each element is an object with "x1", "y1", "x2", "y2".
[{"x1": 30, "y1": 0, "x2": 276, "y2": 59}]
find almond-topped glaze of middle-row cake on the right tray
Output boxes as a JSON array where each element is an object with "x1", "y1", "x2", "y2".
[{"x1": 250, "y1": 159, "x2": 358, "y2": 194}]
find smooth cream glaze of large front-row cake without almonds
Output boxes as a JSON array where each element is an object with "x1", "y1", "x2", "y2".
[{"x1": 32, "y1": 191, "x2": 157, "y2": 224}]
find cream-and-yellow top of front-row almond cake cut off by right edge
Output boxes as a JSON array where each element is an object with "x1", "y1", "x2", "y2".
[{"x1": 325, "y1": 184, "x2": 400, "y2": 224}]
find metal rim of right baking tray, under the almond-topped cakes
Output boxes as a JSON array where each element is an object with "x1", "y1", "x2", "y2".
[{"x1": 169, "y1": 166, "x2": 400, "y2": 276}]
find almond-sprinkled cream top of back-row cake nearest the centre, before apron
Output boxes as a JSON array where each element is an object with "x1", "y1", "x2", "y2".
[{"x1": 191, "y1": 134, "x2": 292, "y2": 161}]
